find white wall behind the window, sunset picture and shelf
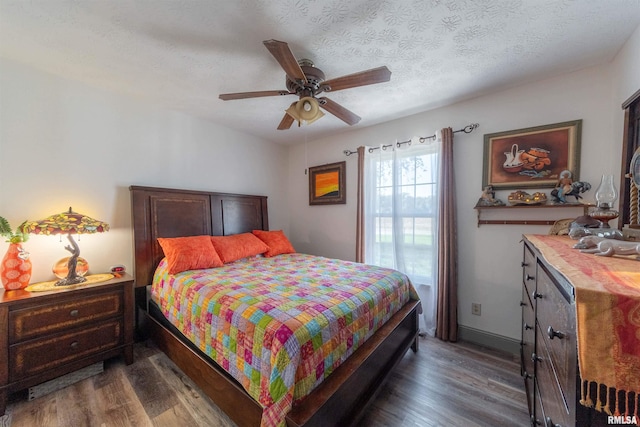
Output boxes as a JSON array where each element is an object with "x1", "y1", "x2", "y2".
[{"x1": 289, "y1": 25, "x2": 640, "y2": 339}]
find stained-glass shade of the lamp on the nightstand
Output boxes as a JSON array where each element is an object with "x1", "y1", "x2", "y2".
[{"x1": 22, "y1": 208, "x2": 109, "y2": 235}]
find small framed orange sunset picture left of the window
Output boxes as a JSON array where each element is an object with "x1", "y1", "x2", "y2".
[{"x1": 309, "y1": 162, "x2": 347, "y2": 205}]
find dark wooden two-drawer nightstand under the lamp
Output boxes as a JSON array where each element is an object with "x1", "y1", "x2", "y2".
[{"x1": 0, "y1": 274, "x2": 134, "y2": 415}]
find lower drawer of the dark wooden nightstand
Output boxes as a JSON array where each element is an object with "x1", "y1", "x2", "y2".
[{"x1": 9, "y1": 319, "x2": 123, "y2": 381}]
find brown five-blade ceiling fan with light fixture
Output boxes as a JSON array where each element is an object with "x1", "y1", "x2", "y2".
[{"x1": 219, "y1": 40, "x2": 391, "y2": 130}]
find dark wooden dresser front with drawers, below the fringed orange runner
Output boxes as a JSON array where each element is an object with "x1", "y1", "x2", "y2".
[{"x1": 520, "y1": 236, "x2": 607, "y2": 427}]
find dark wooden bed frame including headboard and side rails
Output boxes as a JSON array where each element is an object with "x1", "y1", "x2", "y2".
[{"x1": 130, "y1": 186, "x2": 419, "y2": 427}]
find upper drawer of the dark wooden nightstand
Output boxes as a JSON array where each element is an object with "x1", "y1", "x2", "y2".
[{"x1": 9, "y1": 290, "x2": 123, "y2": 344}]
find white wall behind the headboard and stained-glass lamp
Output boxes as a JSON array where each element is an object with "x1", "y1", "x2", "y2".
[{"x1": 0, "y1": 61, "x2": 289, "y2": 281}]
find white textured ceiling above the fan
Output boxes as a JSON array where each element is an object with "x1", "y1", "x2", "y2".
[{"x1": 0, "y1": 0, "x2": 640, "y2": 143}]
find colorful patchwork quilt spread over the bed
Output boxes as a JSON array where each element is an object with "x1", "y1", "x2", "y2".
[{"x1": 151, "y1": 253, "x2": 418, "y2": 427}]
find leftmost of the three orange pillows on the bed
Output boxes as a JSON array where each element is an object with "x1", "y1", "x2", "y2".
[{"x1": 158, "y1": 236, "x2": 224, "y2": 274}]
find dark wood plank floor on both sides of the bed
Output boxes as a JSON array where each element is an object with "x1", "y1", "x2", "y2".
[{"x1": 0, "y1": 338, "x2": 528, "y2": 427}]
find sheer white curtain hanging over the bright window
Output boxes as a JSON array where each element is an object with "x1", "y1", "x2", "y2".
[{"x1": 364, "y1": 138, "x2": 441, "y2": 335}]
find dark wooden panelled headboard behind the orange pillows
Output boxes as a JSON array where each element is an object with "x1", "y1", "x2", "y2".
[{"x1": 129, "y1": 186, "x2": 269, "y2": 287}]
